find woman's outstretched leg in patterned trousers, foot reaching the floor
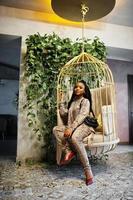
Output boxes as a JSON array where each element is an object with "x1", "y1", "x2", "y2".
[{"x1": 71, "y1": 124, "x2": 93, "y2": 184}]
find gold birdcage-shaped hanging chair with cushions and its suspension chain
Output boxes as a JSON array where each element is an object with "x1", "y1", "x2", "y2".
[{"x1": 57, "y1": 5, "x2": 119, "y2": 155}]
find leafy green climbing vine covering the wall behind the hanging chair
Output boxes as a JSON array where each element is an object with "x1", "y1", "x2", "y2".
[{"x1": 24, "y1": 33, "x2": 106, "y2": 161}]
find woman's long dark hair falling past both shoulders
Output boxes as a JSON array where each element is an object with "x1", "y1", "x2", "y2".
[{"x1": 68, "y1": 80, "x2": 92, "y2": 112}]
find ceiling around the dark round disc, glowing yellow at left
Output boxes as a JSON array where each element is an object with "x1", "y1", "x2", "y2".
[{"x1": 0, "y1": 0, "x2": 133, "y2": 27}]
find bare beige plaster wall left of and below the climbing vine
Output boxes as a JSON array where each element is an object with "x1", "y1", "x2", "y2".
[{"x1": 17, "y1": 65, "x2": 45, "y2": 161}]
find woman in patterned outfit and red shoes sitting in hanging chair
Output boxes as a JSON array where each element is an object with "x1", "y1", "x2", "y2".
[{"x1": 53, "y1": 80, "x2": 95, "y2": 185}]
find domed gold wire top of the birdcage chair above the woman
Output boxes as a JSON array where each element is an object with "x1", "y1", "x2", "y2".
[{"x1": 59, "y1": 52, "x2": 114, "y2": 89}]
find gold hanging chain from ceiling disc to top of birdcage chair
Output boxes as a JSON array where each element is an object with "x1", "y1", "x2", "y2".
[{"x1": 81, "y1": 4, "x2": 89, "y2": 52}]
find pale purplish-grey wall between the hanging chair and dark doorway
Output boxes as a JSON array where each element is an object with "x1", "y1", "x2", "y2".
[{"x1": 108, "y1": 60, "x2": 133, "y2": 142}]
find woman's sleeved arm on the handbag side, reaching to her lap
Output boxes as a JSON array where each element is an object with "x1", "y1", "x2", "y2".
[{"x1": 68, "y1": 99, "x2": 90, "y2": 131}]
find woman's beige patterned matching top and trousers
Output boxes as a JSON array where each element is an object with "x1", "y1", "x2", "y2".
[{"x1": 53, "y1": 97, "x2": 94, "y2": 168}]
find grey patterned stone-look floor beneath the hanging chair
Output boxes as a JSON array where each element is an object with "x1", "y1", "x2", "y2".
[{"x1": 0, "y1": 145, "x2": 133, "y2": 200}]
